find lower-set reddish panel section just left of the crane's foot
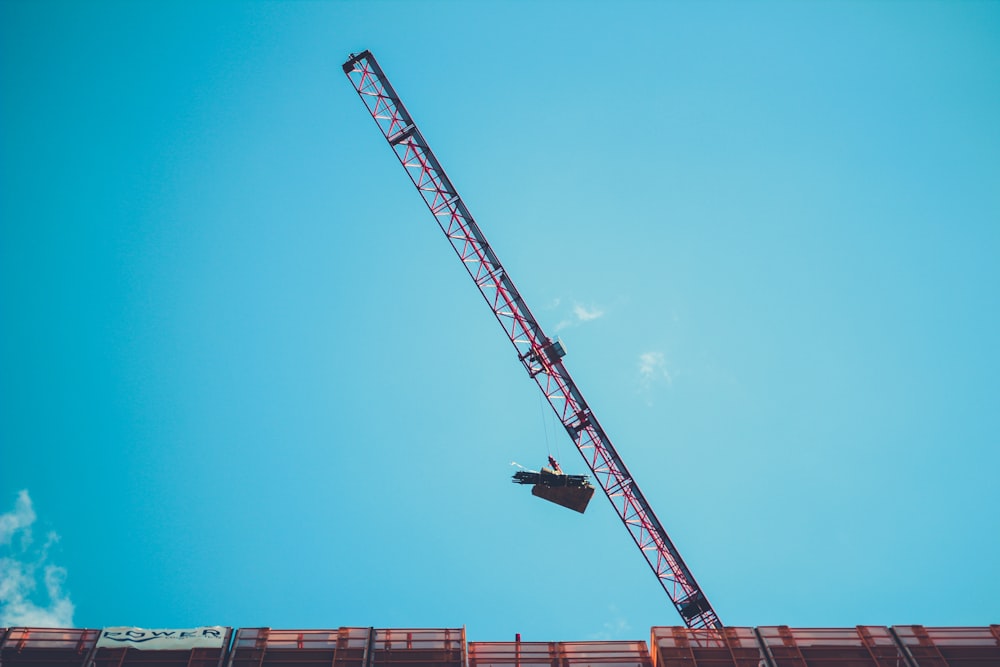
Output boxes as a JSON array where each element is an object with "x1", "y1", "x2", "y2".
[{"x1": 469, "y1": 641, "x2": 653, "y2": 667}]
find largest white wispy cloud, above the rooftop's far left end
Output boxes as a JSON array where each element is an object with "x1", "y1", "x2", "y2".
[{"x1": 0, "y1": 491, "x2": 74, "y2": 628}]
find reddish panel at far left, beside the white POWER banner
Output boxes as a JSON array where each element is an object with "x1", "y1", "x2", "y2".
[{"x1": 0, "y1": 628, "x2": 101, "y2": 667}]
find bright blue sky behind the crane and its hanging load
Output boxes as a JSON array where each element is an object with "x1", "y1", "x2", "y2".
[{"x1": 0, "y1": 0, "x2": 1000, "y2": 641}]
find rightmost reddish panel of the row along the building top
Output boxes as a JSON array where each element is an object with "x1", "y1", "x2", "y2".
[{"x1": 892, "y1": 625, "x2": 1000, "y2": 667}]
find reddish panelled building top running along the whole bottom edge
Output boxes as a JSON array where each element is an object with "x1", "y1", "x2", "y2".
[{"x1": 0, "y1": 625, "x2": 1000, "y2": 667}]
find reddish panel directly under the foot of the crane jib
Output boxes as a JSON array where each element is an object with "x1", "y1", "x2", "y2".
[{"x1": 650, "y1": 627, "x2": 764, "y2": 667}]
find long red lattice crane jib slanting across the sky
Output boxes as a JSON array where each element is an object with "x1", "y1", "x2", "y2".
[{"x1": 343, "y1": 50, "x2": 722, "y2": 629}]
